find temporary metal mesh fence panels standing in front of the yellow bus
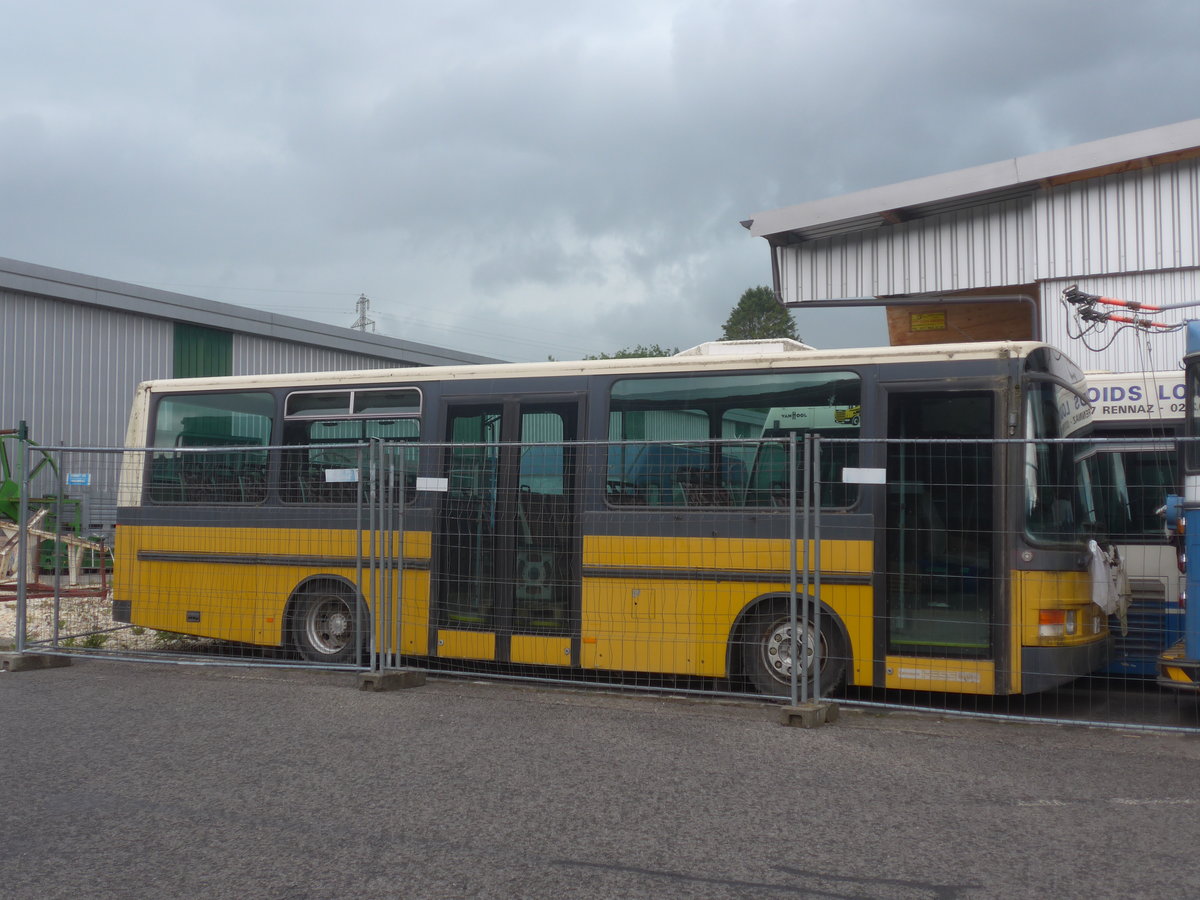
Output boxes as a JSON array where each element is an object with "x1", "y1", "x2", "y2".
[{"x1": 0, "y1": 439, "x2": 1200, "y2": 730}]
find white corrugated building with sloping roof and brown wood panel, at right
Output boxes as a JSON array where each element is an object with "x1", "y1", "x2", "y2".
[{"x1": 743, "y1": 119, "x2": 1200, "y2": 372}]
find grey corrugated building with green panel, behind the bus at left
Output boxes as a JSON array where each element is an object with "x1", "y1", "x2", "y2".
[{"x1": 0, "y1": 258, "x2": 496, "y2": 446}]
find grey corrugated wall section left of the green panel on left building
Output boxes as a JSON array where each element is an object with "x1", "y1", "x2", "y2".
[{"x1": 0, "y1": 290, "x2": 172, "y2": 446}]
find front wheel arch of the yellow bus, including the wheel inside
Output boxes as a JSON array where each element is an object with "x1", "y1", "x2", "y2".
[{"x1": 730, "y1": 594, "x2": 850, "y2": 696}]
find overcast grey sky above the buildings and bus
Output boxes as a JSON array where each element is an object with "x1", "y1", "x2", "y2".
[{"x1": 0, "y1": 0, "x2": 1200, "y2": 360}]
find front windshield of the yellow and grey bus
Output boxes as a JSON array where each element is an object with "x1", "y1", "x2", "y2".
[{"x1": 1024, "y1": 379, "x2": 1102, "y2": 544}]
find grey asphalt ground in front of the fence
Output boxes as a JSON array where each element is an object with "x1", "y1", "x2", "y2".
[{"x1": 0, "y1": 659, "x2": 1200, "y2": 900}]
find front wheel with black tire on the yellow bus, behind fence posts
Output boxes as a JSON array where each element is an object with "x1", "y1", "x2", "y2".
[{"x1": 742, "y1": 604, "x2": 847, "y2": 697}]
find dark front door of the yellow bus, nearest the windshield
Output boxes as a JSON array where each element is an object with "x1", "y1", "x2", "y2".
[{"x1": 876, "y1": 390, "x2": 1010, "y2": 694}]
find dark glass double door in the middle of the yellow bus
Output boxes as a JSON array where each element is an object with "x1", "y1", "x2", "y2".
[{"x1": 430, "y1": 398, "x2": 582, "y2": 665}]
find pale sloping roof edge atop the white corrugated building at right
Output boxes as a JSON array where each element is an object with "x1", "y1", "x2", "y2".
[{"x1": 749, "y1": 119, "x2": 1200, "y2": 238}]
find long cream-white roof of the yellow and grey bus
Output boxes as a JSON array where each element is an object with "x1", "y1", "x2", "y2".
[{"x1": 139, "y1": 341, "x2": 1070, "y2": 392}]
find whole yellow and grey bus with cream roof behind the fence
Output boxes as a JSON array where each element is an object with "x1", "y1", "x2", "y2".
[{"x1": 114, "y1": 341, "x2": 1109, "y2": 695}]
